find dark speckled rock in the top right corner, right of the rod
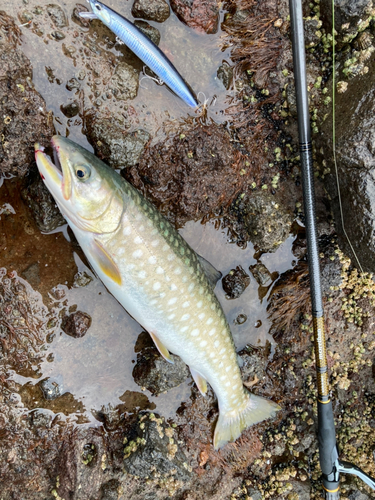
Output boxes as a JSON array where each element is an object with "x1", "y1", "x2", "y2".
[{"x1": 320, "y1": 0, "x2": 375, "y2": 48}]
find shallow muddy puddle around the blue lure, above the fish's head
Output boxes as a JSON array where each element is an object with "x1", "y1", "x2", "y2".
[{"x1": 2, "y1": 0, "x2": 236, "y2": 143}]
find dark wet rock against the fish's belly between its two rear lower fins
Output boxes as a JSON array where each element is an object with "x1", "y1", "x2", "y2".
[{"x1": 133, "y1": 347, "x2": 189, "y2": 394}]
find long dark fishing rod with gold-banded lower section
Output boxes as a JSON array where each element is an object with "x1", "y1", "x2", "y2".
[{"x1": 289, "y1": 0, "x2": 375, "y2": 500}]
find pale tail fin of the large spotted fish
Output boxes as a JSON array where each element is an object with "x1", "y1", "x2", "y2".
[{"x1": 214, "y1": 389, "x2": 281, "y2": 450}]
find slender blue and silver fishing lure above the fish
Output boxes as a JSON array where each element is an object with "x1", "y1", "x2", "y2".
[{"x1": 79, "y1": 0, "x2": 198, "y2": 108}]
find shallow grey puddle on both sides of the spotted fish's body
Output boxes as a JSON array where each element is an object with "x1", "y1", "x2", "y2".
[{"x1": 7, "y1": 213, "x2": 294, "y2": 425}]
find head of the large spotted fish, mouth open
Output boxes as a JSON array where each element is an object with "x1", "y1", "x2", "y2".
[{"x1": 35, "y1": 136, "x2": 124, "y2": 233}]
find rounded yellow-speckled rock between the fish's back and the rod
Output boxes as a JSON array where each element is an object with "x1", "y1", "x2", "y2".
[{"x1": 243, "y1": 191, "x2": 292, "y2": 252}]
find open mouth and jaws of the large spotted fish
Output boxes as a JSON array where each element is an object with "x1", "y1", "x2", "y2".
[{"x1": 35, "y1": 136, "x2": 72, "y2": 200}]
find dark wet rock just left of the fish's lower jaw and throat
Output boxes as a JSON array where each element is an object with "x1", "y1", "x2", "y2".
[{"x1": 21, "y1": 176, "x2": 66, "y2": 233}]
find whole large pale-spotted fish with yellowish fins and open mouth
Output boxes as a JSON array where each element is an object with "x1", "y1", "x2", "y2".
[{"x1": 35, "y1": 136, "x2": 280, "y2": 449}]
